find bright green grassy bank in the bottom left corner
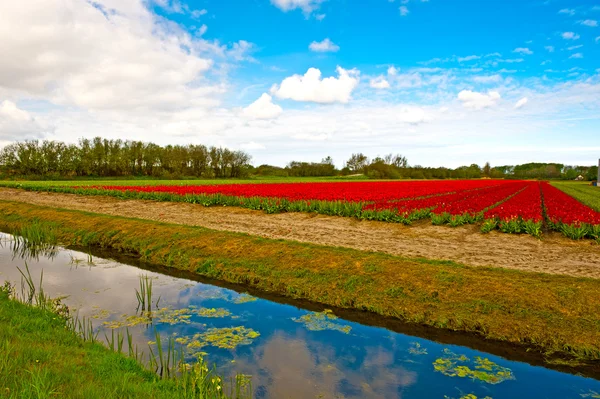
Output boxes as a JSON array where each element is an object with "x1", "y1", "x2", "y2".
[{"x1": 0, "y1": 289, "x2": 244, "y2": 399}]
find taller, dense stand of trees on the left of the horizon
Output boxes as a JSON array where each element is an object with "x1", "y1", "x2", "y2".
[{"x1": 0, "y1": 137, "x2": 252, "y2": 178}]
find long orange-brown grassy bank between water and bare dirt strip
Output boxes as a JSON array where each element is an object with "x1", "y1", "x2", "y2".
[{"x1": 0, "y1": 202, "x2": 600, "y2": 360}]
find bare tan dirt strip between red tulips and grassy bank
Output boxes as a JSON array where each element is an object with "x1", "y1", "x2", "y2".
[{"x1": 0, "y1": 189, "x2": 600, "y2": 278}]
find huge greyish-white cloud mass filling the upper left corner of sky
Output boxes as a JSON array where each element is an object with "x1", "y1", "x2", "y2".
[{"x1": 0, "y1": 0, "x2": 234, "y2": 111}]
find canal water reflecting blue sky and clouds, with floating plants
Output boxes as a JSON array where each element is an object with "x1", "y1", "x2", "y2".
[{"x1": 0, "y1": 233, "x2": 600, "y2": 399}]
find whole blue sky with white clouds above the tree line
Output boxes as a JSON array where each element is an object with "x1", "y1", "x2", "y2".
[{"x1": 0, "y1": 0, "x2": 600, "y2": 167}]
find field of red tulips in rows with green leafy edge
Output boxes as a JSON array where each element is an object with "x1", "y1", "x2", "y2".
[{"x1": 46, "y1": 180, "x2": 600, "y2": 240}]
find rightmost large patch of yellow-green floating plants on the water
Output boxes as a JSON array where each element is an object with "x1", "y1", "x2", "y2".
[{"x1": 433, "y1": 349, "x2": 515, "y2": 384}]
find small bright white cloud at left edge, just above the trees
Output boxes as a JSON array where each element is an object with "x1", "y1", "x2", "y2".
[{"x1": 0, "y1": 100, "x2": 43, "y2": 141}]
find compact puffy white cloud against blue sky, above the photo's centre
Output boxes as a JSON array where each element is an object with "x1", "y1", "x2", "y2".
[{"x1": 271, "y1": 67, "x2": 360, "y2": 104}]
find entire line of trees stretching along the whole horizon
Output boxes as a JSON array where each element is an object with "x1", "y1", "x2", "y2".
[{"x1": 0, "y1": 137, "x2": 598, "y2": 180}]
